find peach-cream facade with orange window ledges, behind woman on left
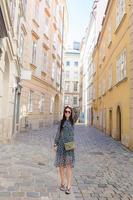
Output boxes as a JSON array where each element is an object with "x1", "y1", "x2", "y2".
[{"x1": 20, "y1": 0, "x2": 67, "y2": 131}]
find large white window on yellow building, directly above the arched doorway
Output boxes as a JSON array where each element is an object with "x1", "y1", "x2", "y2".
[{"x1": 116, "y1": 49, "x2": 126, "y2": 82}]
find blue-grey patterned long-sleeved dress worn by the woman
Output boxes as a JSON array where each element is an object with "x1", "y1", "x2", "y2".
[{"x1": 54, "y1": 120, "x2": 75, "y2": 167}]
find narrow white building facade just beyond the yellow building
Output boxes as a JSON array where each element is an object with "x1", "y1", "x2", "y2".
[{"x1": 80, "y1": 0, "x2": 108, "y2": 125}]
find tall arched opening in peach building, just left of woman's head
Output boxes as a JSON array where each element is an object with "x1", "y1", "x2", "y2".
[{"x1": 54, "y1": 94, "x2": 60, "y2": 123}]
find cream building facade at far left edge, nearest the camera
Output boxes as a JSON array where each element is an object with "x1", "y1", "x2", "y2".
[{"x1": 0, "y1": 0, "x2": 21, "y2": 141}]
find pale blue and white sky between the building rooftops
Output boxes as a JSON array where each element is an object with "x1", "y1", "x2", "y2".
[{"x1": 67, "y1": 0, "x2": 93, "y2": 45}]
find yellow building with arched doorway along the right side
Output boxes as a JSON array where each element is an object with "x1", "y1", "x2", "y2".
[{"x1": 92, "y1": 0, "x2": 133, "y2": 148}]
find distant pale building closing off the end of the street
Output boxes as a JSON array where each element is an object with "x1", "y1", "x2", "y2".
[{"x1": 63, "y1": 43, "x2": 80, "y2": 109}]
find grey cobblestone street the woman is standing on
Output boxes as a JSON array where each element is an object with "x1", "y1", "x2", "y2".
[{"x1": 0, "y1": 125, "x2": 133, "y2": 200}]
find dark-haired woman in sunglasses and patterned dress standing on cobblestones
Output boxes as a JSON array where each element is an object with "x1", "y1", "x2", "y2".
[{"x1": 54, "y1": 106, "x2": 75, "y2": 194}]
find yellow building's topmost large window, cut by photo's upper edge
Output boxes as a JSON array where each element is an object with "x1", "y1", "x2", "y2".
[{"x1": 116, "y1": 0, "x2": 125, "y2": 27}]
